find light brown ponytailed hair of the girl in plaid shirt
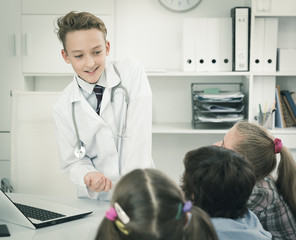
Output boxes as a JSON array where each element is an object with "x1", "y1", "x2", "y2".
[{"x1": 233, "y1": 121, "x2": 296, "y2": 217}]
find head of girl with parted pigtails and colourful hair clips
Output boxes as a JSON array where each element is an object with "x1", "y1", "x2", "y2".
[{"x1": 96, "y1": 169, "x2": 217, "y2": 240}]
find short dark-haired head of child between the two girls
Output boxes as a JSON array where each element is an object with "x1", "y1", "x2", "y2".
[{"x1": 182, "y1": 146, "x2": 255, "y2": 219}]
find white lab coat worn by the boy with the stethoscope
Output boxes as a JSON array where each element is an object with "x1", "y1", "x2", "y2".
[{"x1": 54, "y1": 59, "x2": 154, "y2": 200}]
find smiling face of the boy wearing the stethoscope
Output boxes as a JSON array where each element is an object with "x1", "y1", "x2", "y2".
[{"x1": 62, "y1": 28, "x2": 110, "y2": 83}]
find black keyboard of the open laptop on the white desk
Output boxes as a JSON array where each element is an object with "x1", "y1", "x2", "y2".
[{"x1": 15, "y1": 203, "x2": 65, "y2": 221}]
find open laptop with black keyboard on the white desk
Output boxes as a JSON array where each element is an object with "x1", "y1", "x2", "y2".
[{"x1": 0, "y1": 189, "x2": 92, "y2": 229}]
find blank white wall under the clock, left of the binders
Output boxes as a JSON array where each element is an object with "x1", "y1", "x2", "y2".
[{"x1": 114, "y1": 0, "x2": 250, "y2": 70}]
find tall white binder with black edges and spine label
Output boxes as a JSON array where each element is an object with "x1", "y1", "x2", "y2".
[{"x1": 231, "y1": 7, "x2": 251, "y2": 71}]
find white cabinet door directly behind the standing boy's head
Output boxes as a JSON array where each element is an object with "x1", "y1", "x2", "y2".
[{"x1": 22, "y1": 15, "x2": 113, "y2": 74}]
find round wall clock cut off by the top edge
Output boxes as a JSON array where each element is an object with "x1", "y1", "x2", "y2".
[{"x1": 159, "y1": 0, "x2": 201, "y2": 12}]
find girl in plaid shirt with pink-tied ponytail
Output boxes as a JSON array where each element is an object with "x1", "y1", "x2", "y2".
[{"x1": 216, "y1": 121, "x2": 296, "y2": 239}]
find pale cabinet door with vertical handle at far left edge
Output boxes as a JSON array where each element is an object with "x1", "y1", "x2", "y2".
[{"x1": 0, "y1": 0, "x2": 23, "y2": 132}]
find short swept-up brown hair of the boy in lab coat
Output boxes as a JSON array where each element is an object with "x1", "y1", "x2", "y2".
[{"x1": 57, "y1": 11, "x2": 107, "y2": 51}]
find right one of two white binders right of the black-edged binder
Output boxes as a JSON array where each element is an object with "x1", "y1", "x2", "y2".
[{"x1": 263, "y1": 18, "x2": 278, "y2": 72}]
